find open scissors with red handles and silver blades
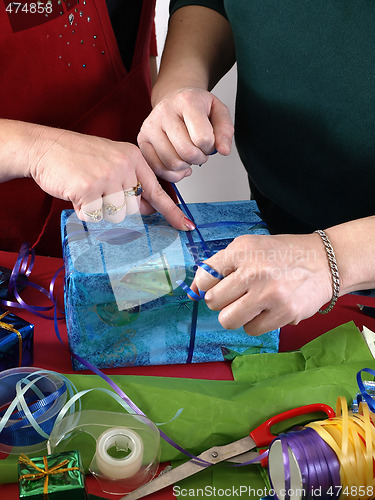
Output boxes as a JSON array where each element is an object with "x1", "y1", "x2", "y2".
[{"x1": 121, "y1": 403, "x2": 335, "y2": 500}]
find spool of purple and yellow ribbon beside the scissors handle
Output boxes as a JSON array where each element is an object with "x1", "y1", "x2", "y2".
[{"x1": 268, "y1": 397, "x2": 375, "y2": 500}]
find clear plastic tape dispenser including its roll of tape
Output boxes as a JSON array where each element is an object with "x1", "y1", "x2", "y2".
[{"x1": 47, "y1": 410, "x2": 160, "y2": 495}]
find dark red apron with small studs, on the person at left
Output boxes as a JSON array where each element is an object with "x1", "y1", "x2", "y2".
[{"x1": 0, "y1": 0, "x2": 155, "y2": 256}]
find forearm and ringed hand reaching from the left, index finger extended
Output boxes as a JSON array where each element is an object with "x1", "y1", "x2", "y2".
[{"x1": 0, "y1": 119, "x2": 191, "y2": 230}]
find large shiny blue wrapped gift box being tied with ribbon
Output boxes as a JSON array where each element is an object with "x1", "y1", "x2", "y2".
[{"x1": 62, "y1": 201, "x2": 279, "y2": 369}]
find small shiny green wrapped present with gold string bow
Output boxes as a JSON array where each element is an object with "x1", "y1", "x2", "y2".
[{"x1": 18, "y1": 451, "x2": 87, "y2": 500}]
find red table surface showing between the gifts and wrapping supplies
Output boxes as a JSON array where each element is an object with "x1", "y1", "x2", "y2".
[{"x1": 0, "y1": 251, "x2": 375, "y2": 500}]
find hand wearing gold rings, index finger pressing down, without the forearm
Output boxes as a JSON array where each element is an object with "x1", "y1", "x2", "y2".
[{"x1": 30, "y1": 127, "x2": 194, "y2": 230}]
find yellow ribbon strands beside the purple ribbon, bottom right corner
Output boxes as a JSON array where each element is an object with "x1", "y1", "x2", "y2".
[{"x1": 306, "y1": 397, "x2": 375, "y2": 500}]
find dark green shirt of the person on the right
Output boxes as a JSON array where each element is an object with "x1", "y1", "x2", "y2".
[{"x1": 171, "y1": 0, "x2": 375, "y2": 232}]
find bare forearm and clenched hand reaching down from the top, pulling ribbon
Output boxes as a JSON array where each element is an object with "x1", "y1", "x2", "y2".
[{"x1": 138, "y1": 6, "x2": 235, "y2": 182}]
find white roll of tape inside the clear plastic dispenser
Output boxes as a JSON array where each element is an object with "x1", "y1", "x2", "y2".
[{"x1": 96, "y1": 427, "x2": 143, "y2": 480}]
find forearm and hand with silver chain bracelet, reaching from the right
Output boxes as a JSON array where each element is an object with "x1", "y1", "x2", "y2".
[{"x1": 192, "y1": 217, "x2": 375, "y2": 335}]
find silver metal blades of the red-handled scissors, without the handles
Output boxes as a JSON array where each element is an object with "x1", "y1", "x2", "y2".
[{"x1": 120, "y1": 436, "x2": 255, "y2": 500}]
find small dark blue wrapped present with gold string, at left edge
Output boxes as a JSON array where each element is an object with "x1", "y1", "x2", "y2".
[{"x1": 0, "y1": 308, "x2": 34, "y2": 371}]
